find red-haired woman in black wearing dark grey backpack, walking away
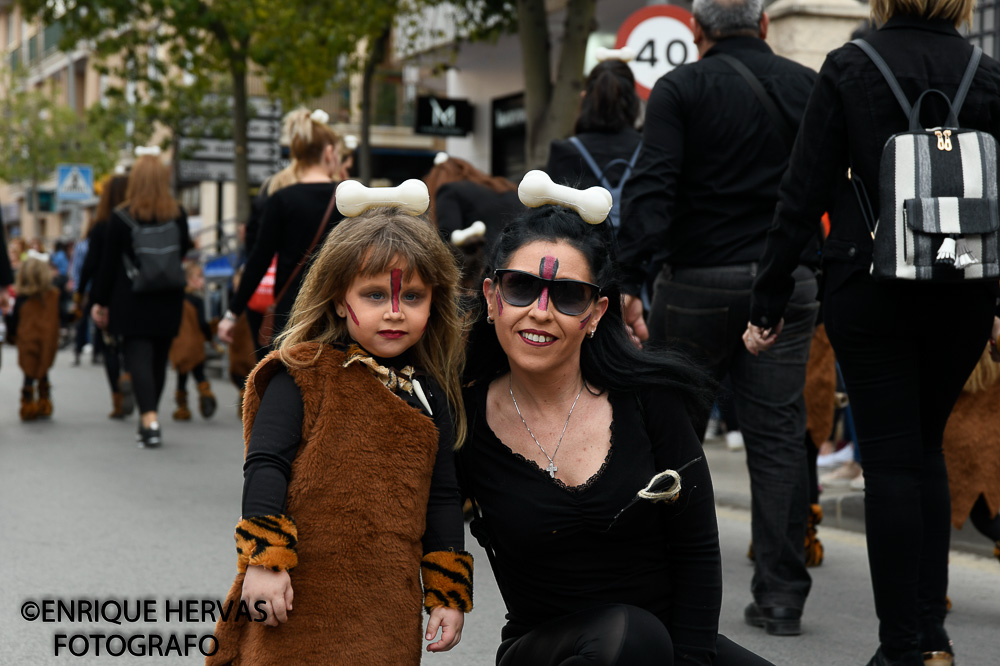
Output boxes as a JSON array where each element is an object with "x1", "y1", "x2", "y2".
[{"x1": 91, "y1": 148, "x2": 193, "y2": 448}]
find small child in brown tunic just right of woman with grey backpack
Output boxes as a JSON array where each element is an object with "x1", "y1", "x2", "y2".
[{"x1": 170, "y1": 261, "x2": 218, "y2": 421}]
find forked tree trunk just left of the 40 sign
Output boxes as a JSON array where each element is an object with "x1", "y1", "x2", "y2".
[{"x1": 517, "y1": 0, "x2": 597, "y2": 169}]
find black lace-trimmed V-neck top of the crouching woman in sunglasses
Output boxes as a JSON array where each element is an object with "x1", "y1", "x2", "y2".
[{"x1": 458, "y1": 383, "x2": 722, "y2": 664}]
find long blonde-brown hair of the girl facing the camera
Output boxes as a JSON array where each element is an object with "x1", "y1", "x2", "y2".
[{"x1": 276, "y1": 208, "x2": 466, "y2": 449}]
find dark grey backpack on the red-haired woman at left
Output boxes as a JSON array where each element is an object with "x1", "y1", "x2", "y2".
[{"x1": 117, "y1": 208, "x2": 187, "y2": 294}]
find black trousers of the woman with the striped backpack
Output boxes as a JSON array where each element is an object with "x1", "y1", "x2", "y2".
[{"x1": 824, "y1": 264, "x2": 995, "y2": 657}]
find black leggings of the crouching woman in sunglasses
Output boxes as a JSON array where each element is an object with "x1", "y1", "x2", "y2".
[{"x1": 497, "y1": 604, "x2": 771, "y2": 666}]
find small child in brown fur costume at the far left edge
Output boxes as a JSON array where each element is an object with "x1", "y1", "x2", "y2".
[{"x1": 9, "y1": 250, "x2": 59, "y2": 421}]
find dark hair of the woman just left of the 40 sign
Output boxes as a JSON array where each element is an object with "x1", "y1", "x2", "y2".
[{"x1": 573, "y1": 60, "x2": 639, "y2": 134}]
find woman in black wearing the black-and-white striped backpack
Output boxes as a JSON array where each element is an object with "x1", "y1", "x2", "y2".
[{"x1": 745, "y1": 0, "x2": 1000, "y2": 666}]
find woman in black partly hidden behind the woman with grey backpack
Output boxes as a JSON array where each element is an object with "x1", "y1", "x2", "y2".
[{"x1": 74, "y1": 175, "x2": 135, "y2": 419}]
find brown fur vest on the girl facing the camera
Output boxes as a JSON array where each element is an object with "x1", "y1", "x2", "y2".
[{"x1": 206, "y1": 343, "x2": 438, "y2": 666}]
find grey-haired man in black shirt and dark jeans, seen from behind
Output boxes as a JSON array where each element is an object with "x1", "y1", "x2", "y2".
[{"x1": 620, "y1": 0, "x2": 819, "y2": 635}]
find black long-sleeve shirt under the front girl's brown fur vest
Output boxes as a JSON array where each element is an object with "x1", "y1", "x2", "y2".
[{"x1": 243, "y1": 359, "x2": 465, "y2": 553}]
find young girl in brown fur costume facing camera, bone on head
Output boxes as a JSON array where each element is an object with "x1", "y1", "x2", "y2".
[{"x1": 206, "y1": 181, "x2": 472, "y2": 665}]
